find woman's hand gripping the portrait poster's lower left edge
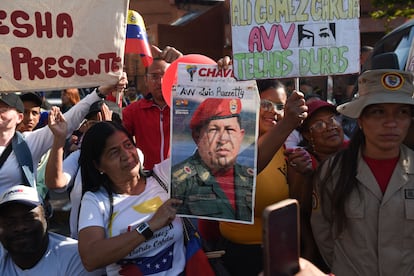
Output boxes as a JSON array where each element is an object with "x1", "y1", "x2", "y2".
[{"x1": 148, "y1": 198, "x2": 183, "y2": 232}]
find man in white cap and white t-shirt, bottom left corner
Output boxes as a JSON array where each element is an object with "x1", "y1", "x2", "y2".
[{"x1": 0, "y1": 185, "x2": 99, "y2": 276}]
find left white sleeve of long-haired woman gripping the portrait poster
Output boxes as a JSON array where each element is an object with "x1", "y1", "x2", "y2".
[{"x1": 79, "y1": 192, "x2": 109, "y2": 231}]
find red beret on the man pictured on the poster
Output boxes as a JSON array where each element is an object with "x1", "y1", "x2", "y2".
[{"x1": 190, "y1": 98, "x2": 241, "y2": 129}]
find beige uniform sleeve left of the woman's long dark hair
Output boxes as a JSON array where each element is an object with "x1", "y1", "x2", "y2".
[{"x1": 311, "y1": 162, "x2": 334, "y2": 267}]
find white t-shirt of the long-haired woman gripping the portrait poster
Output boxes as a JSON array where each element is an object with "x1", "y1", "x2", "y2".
[{"x1": 79, "y1": 174, "x2": 185, "y2": 276}]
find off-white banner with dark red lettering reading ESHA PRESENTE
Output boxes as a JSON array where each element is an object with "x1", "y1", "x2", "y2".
[{"x1": 0, "y1": 0, "x2": 129, "y2": 92}]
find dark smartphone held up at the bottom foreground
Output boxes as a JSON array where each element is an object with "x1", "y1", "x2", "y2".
[{"x1": 263, "y1": 199, "x2": 300, "y2": 276}]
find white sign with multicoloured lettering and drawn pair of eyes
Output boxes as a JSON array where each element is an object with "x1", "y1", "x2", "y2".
[{"x1": 230, "y1": 0, "x2": 360, "y2": 80}]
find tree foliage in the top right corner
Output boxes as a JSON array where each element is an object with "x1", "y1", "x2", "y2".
[{"x1": 371, "y1": 0, "x2": 414, "y2": 21}]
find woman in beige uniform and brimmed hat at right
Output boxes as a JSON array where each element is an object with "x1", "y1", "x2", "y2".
[{"x1": 311, "y1": 69, "x2": 414, "y2": 275}]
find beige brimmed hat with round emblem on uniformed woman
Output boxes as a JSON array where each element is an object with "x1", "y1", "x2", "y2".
[{"x1": 337, "y1": 69, "x2": 414, "y2": 118}]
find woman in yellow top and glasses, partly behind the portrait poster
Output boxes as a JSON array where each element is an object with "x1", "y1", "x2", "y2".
[{"x1": 219, "y1": 80, "x2": 306, "y2": 275}]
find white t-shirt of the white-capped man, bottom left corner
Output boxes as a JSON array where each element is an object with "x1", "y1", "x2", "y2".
[{"x1": 0, "y1": 232, "x2": 100, "y2": 276}]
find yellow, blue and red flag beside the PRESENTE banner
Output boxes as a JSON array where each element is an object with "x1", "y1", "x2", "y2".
[{"x1": 125, "y1": 10, "x2": 152, "y2": 67}]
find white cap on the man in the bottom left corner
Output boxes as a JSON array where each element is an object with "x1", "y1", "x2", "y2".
[{"x1": 0, "y1": 185, "x2": 43, "y2": 207}]
